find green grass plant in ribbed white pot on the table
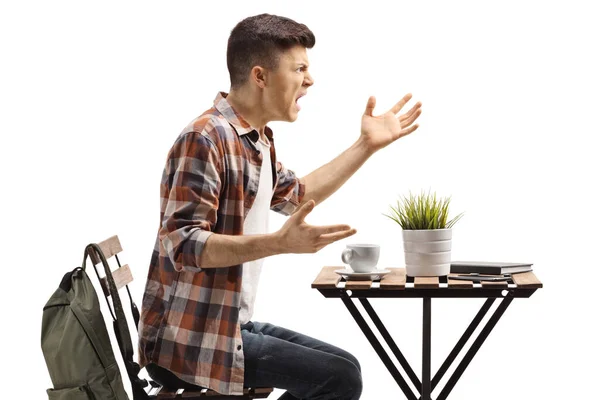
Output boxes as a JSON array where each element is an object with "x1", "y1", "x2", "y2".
[{"x1": 384, "y1": 193, "x2": 463, "y2": 276}]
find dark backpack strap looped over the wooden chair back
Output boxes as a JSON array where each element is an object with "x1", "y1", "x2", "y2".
[{"x1": 82, "y1": 243, "x2": 148, "y2": 399}]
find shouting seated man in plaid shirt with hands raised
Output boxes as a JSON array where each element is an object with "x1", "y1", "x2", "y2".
[{"x1": 139, "y1": 14, "x2": 421, "y2": 399}]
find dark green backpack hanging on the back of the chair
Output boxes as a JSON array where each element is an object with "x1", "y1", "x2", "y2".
[{"x1": 42, "y1": 246, "x2": 131, "y2": 400}]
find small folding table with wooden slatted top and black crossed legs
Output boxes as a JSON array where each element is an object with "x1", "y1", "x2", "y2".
[{"x1": 312, "y1": 266, "x2": 542, "y2": 400}]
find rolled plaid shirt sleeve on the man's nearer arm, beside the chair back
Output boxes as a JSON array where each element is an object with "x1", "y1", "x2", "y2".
[{"x1": 160, "y1": 132, "x2": 222, "y2": 272}]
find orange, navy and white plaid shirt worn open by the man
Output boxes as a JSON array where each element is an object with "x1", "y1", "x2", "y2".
[{"x1": 138, "y1": 92, "x2": 304, "y2": 395}]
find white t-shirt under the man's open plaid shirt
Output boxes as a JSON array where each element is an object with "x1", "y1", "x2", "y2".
[{"x1": 239, "y1": 138, "x2": 273, "y2": 324}]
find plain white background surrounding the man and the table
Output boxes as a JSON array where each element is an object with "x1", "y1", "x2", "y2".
[{"x1": 0, "y1": 0, "x2": 600, "y2": 400}]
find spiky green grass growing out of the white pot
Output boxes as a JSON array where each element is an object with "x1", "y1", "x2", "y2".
[{"x1": 383, "y1": 192, "x2": 464, "y2": 230}]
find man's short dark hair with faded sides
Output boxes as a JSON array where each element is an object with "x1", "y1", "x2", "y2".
[{"x1": 227, "y1": 14, "x2": 315, "y2": 89}]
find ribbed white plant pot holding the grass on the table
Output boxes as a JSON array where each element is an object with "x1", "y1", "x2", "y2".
[{"x1": 402, "y1": 229, "x2": 452, "y2": 276}]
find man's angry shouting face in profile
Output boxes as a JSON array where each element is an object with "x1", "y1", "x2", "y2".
[{"x1": 264, "y1": 46, "x2": 314, "y2": 122}]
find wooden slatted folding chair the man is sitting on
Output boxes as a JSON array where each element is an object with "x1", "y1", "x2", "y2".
[{"x1": 86, "y1": 235, "x2": 273, "y2": 400}]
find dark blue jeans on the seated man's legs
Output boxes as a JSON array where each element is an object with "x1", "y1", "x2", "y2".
[{"x1": 241, "y1": 321, "x2": 362, "y2": 400}]
